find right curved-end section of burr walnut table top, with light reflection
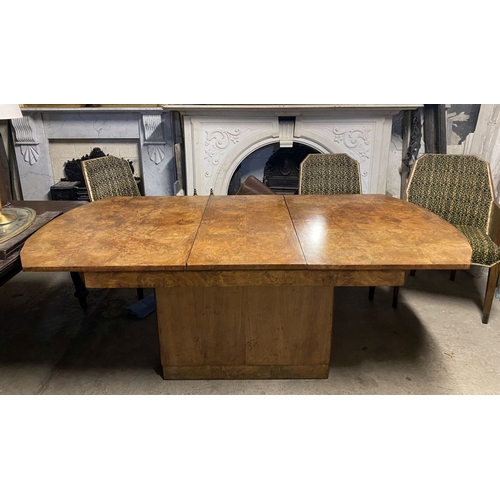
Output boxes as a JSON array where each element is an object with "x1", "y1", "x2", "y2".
[{"x1": 285, "y1": 195, "x2": 472, "y2": 270}]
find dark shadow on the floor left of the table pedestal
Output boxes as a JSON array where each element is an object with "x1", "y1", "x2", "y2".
[{"x1": 0, "y1": 273, "x2": 160, "y2": 376}]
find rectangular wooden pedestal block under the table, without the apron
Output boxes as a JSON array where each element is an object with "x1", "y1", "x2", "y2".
[{"x1": 156, "y1": 286, "x2": 333, "y2": 379}]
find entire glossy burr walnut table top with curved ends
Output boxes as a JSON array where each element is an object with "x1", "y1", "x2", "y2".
[{"x1": 21, "y1": 195, "x2": 471, "y2": 272}]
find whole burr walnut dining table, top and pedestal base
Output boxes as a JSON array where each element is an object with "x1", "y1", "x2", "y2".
[{"x1": 21, "y1": 195, "x2": 471, "y2": 379}]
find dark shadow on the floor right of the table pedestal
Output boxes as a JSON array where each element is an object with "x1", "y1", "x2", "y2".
[{"x1": 330, "y1": 271, "x2": 493, "y2": 367}]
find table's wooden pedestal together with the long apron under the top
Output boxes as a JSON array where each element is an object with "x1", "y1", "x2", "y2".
[{"x1": 85, "y1": 269, "x2": 405, "y2": 380}]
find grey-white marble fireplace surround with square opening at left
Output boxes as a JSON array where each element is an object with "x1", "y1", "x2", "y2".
[{"x1": 12, "y1": 107, "x2": 175, "y2": 200}]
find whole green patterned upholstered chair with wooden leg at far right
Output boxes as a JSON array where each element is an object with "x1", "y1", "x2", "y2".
[{"x1": 405, "y1": 154, "x2": 500, "y2": 324}]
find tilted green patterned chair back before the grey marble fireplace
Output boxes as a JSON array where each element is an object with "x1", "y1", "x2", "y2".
[{"x1": 82, "y1": 156, "x2": 141, "y2": 201}]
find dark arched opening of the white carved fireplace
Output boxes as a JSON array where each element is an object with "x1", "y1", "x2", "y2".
[{"x1": 227, "y1": 142, "x2": 321, "y2": 195}]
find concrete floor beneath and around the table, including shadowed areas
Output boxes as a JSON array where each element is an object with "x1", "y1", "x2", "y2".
[{"x1": 0, "y1": 271, "x2": 500, "y2": 394}]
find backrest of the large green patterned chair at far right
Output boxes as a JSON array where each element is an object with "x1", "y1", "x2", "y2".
[{"x1": 406, "y1": 154, "x2": 494, "y2": 231}]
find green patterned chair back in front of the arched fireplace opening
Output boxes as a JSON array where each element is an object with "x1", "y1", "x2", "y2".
[{"x1": 299, "y1": 153, "x2": 361, "y2": 194}]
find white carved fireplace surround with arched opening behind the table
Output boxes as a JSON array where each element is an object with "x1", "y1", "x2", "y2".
[{"x1": 164, "y1": 104, "x2": 420, "y2": 196}]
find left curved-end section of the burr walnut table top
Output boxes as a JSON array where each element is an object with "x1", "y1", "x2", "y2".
[{"x1": 21, "y1": 196, "x2": 208, "y2": 272}]
